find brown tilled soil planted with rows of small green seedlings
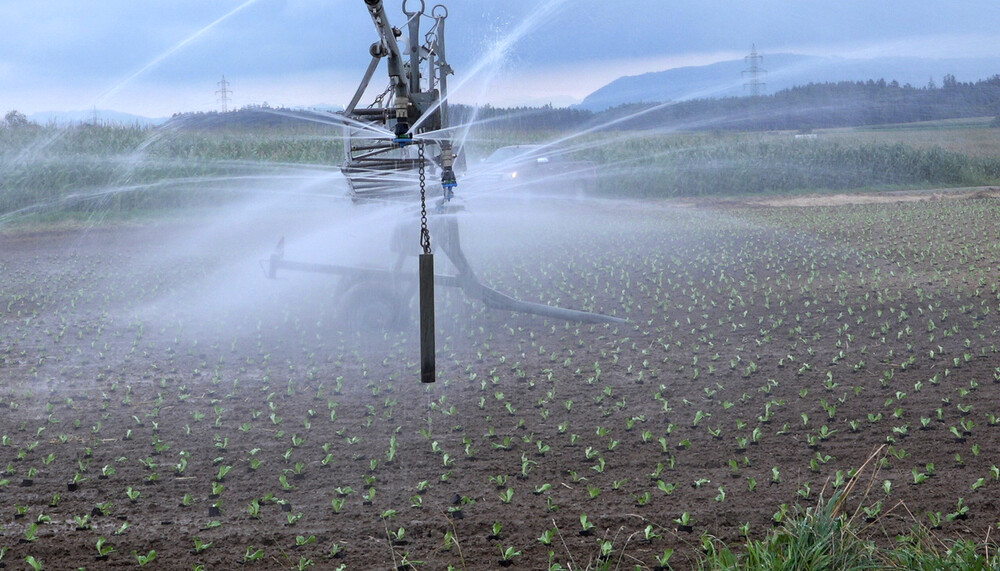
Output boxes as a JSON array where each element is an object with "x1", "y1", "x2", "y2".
[{"x1": 0, "y1": 196, "x2": 1000, "y2": 569}]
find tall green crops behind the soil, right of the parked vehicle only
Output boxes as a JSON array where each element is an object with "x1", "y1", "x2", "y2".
[{"x1": 580, "y1": 135, "x2": 1000, "y2": 198}]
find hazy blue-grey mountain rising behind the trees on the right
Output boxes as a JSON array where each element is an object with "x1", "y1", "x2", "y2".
[{"x1": 578, "y1": 53, "x2": 1000, "y2": 111}]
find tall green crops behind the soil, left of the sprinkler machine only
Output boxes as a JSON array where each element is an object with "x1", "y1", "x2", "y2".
[{"x1": 0, "y1": 125, "x2": 343, "y2": 219}]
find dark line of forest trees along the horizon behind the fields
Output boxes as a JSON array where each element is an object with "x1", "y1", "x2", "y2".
[{"x1": 11, "y1": 75, "x2": 1000, "y2": 133}]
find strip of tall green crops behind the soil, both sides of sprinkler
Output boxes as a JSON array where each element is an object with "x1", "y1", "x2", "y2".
[{"x1": 0, "y1": 119, "x2": 1000, "y2": 223}]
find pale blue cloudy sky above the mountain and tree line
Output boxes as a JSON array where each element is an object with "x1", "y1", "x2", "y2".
[{"x1": 0, "y1": 0, "x2": 1000, "y2": 117}]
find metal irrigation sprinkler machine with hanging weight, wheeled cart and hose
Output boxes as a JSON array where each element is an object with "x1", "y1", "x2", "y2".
[{"x1": 267, "y1": 0, "x2": 625, "y2": 383}]
